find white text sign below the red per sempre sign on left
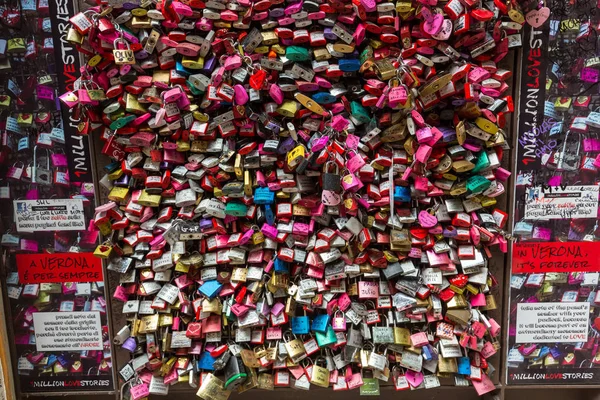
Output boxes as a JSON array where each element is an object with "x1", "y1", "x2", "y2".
[{"x1": 33, "y1": 311, "x2": 103, "y2": 351}]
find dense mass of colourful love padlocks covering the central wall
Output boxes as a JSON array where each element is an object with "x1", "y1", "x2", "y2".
[{"x1": 60, "y1": 0, "x2": 525, "y2": 400}]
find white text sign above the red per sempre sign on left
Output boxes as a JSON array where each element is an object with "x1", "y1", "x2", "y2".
[{"x1": 14, "y1": 199, "x2": 86, "y2": 232}]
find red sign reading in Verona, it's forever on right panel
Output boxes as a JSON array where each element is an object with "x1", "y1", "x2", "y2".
[{"x1": 512, "y1": 242, "x2": 600, "y2": 274}]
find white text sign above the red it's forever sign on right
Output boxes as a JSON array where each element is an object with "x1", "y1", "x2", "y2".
[{"x1": 525, "y1": 185, "x2": 598, "y2": 220}]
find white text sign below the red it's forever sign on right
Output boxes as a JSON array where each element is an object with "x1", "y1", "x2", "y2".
[{"x1": 516, "y1": 302, "x2": 590, "y2": 343}]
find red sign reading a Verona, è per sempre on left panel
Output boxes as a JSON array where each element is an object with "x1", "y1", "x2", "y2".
[{"x1": 17, "y1": 253, "x2": 102, "y2": 283}]
